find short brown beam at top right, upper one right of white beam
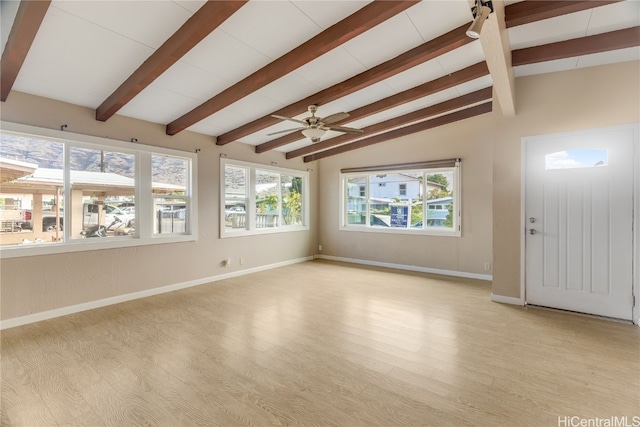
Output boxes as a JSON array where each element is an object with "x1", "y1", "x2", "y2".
[{"x1": 505, "y1": 0, "x2": 620, "y2": 28}]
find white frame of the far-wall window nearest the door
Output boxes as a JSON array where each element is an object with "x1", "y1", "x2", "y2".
[{"x1": 339, "y1": 161, "x2": 462, "y2": 237}]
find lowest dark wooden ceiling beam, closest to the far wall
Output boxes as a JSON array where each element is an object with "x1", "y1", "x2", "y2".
[{"x1": 303, "y1": 101, "x2": 492, "y2": 163}]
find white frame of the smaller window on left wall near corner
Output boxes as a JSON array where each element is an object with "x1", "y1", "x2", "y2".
[{"x1": 220, "y1": 157, "x2": 309, "y2": 239}]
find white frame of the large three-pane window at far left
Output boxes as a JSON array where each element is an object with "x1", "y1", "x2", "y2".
[{"x1": 0, "y1": 122, "x2": 198, "y2": 259}]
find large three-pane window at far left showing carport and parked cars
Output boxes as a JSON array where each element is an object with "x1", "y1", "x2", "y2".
[{"x1": 0, "y1": 123, "x2": 196, "y2": 257}]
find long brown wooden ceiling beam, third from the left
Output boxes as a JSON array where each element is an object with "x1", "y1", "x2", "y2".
[{"x1": 167, "y1": 0, "x2": 419, "y2": 135}]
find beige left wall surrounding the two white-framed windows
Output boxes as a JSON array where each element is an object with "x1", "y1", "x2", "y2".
[{"x1": 0, "y1": 92, "x2": 318, "y2": 319}]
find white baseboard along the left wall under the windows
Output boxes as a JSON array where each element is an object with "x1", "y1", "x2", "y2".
[{"x1": 0, "y1": 256, "x2": 313, "y2": 330}]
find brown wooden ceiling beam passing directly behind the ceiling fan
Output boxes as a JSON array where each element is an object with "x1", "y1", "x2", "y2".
[{"x1": 255, "y1": 61, "x2": 489, "y2": 153}]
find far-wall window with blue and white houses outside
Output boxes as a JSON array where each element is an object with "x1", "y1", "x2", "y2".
[{"x1": 340, "y1": 159, "x2": 461, "y2": 236}]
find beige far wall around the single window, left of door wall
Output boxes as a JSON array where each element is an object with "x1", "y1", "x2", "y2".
[{"x1": 319, "y1": 108, "x2": 494, "y2": 274}]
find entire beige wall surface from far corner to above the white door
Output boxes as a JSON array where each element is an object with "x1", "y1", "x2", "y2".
[{"x1": 318, "y1": 61, "x2": 640, "y2": 298}]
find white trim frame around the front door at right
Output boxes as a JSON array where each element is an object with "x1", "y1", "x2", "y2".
[{"x1": 520, "y1": 123, "x2": 640, "y2": 327}]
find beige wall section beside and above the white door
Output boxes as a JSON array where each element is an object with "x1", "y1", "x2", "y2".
[{"x1": 493, "y1": 61, "x2": 640, "y2": 298}]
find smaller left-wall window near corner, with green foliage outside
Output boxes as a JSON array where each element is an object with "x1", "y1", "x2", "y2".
[{"x1": 220, "y1": 158, "x2": 308, "y2": 237}]
